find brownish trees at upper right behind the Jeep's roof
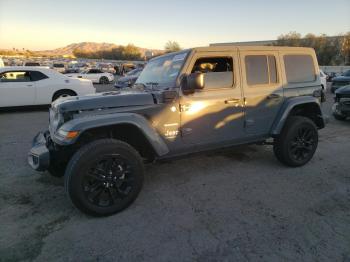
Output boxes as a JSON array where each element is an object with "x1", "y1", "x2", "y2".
[{"x1": 272, "y1": 32, "x2": 350, "y2": 65}]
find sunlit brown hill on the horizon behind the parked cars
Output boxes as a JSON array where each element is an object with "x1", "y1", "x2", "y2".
[{"x1": 36, "y1": 42, "x2": 163, "y2": 56}]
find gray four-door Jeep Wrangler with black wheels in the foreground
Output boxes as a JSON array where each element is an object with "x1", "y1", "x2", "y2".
[{"x1": 28, "y1": 46, "x2": 325, "y2": 216}]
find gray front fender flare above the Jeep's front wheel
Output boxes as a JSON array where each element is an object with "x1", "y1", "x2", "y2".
[{"x1": 51, "y1": 113, "x2": 169, "y2": 156}]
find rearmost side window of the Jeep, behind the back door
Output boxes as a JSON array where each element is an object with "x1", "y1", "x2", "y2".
[{"x1": 284, "y1": 55, "x2": 316, "y2": 83}]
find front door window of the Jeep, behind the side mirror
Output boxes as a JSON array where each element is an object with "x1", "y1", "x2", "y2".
[{"x1": 192, "y1": 57, "x2": 233, "y2": 89}]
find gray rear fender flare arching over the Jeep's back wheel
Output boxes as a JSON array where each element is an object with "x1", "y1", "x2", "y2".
[{"x1": 270, "y1": 96, "x2": 325, "y2": 136}]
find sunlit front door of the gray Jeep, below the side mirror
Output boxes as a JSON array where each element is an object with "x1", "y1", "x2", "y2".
[{"x1": 180, "y1": 51, "x2": 244, "y2": 144}]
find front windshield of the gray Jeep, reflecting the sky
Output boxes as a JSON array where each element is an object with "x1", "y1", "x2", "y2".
[{"x1": 135, "y1": 51, "x2": 188, "y2": 88}]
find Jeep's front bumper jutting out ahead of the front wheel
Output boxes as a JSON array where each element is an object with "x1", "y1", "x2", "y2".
[{"x1": 28, "y1": 131, "x2": 50, "y2": 171}]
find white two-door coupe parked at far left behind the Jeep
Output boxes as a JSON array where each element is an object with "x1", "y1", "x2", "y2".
[{"x1": 0, "y1": 66, "x2": 96, "y2": 108}]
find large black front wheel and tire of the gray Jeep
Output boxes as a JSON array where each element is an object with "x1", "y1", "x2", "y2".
[{"x1": 65, "y1": 139, "x2": 144, "y2": 216}]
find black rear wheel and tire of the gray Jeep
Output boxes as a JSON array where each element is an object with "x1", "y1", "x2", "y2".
[{"x1": 273, "y1": 116, "x2": 318, "y2": 167}]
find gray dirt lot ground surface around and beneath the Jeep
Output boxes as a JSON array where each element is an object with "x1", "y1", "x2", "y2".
[{"x1": 0, "y1": 86, "x2": 350, "y2": 261}]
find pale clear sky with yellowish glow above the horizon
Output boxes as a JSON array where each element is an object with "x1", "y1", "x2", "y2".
[{"x1": 0, "y1": 0, "x2": 350, "y2": 50}]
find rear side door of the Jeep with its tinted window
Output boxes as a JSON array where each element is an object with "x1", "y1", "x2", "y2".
[{"x1": 241, "y1": 51, "x2": 283, "y2": 136}]
